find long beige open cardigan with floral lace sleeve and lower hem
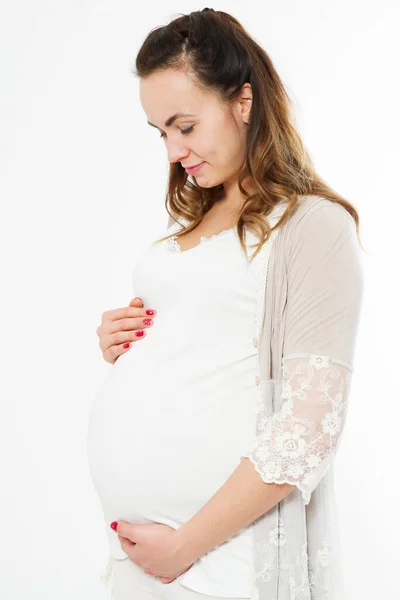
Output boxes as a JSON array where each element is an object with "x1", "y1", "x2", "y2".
[{"x1": 102, "y1": 196, "x2": 363, "y2": 600}]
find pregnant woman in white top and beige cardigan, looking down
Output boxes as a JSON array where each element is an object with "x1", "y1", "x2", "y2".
[{"x1": 88, "y1": 9, "x2": 363, "y2": 600}]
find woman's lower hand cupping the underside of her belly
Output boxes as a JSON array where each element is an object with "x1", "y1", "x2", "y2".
[{"x1": 115, "y1": 521, "x2": 195, "y2": 583}]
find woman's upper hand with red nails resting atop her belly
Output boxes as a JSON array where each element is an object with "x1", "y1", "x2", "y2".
[{"x1": 96, "y1": 298, "x2": 156, "y2": 364}]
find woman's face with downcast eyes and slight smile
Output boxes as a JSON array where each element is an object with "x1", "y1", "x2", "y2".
[{"x1": 140, "y1": 69, "x2": 252, "y2": 188}]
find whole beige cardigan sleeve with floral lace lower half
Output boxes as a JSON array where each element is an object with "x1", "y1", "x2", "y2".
[{"x1": 242, "y1": 205, "x2": 363, "y2": 504}]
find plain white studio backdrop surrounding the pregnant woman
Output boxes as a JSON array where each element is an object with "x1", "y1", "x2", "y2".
[{"x1": 0, "y1": 0, "x2": 400, "y2": 600}]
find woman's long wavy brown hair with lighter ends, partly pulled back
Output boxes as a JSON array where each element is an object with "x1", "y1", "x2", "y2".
[{"x1": 133, "y1": 8, "x2": 361, "y2": 258}]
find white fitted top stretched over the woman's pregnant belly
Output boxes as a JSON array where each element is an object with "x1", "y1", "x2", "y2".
[{"x1": 88, "y1": 213, "x2": 278, "y2": 598}]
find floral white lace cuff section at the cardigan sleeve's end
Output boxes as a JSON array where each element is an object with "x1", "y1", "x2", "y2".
[{"x1": 241, "y1": 353, "x2": 351, "y2": 504}]
